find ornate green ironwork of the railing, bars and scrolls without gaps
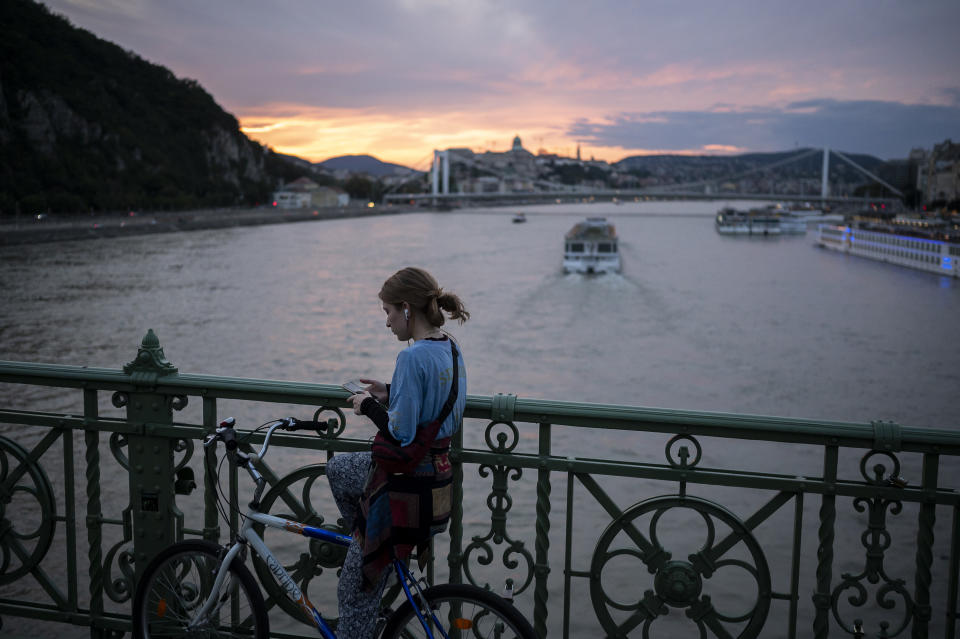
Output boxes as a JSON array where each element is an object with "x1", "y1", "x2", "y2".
[{"x1": 0, "y1": 348, "x2": 960, "y2": 638}]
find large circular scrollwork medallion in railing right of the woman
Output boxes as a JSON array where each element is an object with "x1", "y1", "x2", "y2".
[{"x1": 590, "y1": 496, "x2": 772, "y2": 638}]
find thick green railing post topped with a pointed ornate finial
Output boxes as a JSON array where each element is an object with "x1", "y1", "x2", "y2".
[{"x1": 123, "y1": 329, "x2": 177, "y2": 587}]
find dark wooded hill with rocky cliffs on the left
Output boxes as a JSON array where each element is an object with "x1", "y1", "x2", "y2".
[{"x1": 0, "y1": 0, "x2": 307, "y2": 214}]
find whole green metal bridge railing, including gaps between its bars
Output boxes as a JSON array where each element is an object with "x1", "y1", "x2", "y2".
[{"x1": 0, "y1": 331, "x2": 960, "y2": 638}]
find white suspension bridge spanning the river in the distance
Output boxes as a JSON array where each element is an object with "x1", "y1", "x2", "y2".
[{"x1": 384, "y1": 148, "x2": 903, "y2": 206}]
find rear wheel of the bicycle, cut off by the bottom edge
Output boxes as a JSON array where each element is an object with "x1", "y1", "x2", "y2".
[{"x1": 381, "y1": 584, "x2": 536, "y2": 639}]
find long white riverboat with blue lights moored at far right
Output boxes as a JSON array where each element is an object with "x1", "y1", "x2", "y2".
[{"x1": 817, "y1": 218, "x2": 960, "y2": 278}]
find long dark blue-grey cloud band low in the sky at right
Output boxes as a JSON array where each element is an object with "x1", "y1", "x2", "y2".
[{"x1": 567, "y1": 97, "x2": 960, "y2": 159}]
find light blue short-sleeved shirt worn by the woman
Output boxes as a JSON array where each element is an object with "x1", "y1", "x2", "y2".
[{"x1": 387, "y1": 338, "x2": 467, "y2": 446}]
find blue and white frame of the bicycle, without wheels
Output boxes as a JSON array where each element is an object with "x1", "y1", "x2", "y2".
[{"x1": 197, "y1": 423, "x2": 449, "y2": 639}]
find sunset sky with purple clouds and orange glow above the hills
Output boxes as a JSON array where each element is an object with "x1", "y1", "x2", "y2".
[{"x1": 44, "y1": 0, "x2": 960, "y2": 170}]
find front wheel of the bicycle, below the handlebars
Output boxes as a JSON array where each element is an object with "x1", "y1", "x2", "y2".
[{"x1": 133, "y1": 539, "x2": 270, "y2": 639}]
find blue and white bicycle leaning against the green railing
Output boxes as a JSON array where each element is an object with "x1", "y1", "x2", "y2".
[{"x1": 133, "y1": 417, "x2": 535, "y2": 639}]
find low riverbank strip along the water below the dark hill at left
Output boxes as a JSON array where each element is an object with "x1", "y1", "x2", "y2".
[{"x1": 0, "y1": 205, "x2": 421, "y2": 246}]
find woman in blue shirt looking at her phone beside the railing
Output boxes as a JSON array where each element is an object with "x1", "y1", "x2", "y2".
[{"x1": 327, "y1": 267, "x2": 470, "y2": 638}]
